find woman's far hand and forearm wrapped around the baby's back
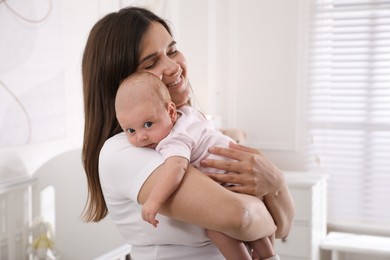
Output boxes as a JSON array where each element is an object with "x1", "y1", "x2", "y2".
[{"x1": 202, "y1": 143, "x2": 295, "y2": 238}]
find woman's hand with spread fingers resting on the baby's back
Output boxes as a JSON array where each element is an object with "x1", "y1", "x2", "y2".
[{"x1": 202, "y1": 142, "x2": 284, "y2": 199}]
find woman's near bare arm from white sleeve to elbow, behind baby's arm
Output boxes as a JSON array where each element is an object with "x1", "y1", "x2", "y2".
[{"x1": 138, "y1": 165, "x2": 276, "y2": 241}]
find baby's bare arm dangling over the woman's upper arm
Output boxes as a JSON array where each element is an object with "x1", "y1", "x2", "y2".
[{"x1": 142, "y1": 156, "x2": 188, "y2": 227}]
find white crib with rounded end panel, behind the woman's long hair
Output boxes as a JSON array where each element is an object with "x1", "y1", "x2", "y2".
[{"x1": 0, "y1": 149, "x2": 130, "y2": 260}]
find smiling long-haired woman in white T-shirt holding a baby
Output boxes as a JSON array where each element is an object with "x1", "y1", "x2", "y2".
[{"x1": 82, "y1": 7, "x2": 294, "y2": 259}]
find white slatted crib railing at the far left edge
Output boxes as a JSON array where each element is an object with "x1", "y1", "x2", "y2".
[{"x1": 0, "y1": 177, "x2": 37, "y2": 259}]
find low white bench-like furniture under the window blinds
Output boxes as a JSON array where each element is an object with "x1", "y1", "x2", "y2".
[{"x1": 321, "y1": 232, "x2": 390, "y2": 260}]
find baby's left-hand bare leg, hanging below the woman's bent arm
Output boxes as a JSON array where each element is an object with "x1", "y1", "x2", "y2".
[{"x1": 206, "y1": 229, "x2": 252, "y2": 260}]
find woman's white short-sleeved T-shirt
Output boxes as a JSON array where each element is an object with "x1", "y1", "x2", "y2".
[{"x1": 99, "y1": 132, "x2": 224, "y2": 260}]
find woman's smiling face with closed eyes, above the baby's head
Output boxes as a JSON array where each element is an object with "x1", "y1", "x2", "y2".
[{"x1": 137, "y1": 22, "x2": 190, "y2": 107}]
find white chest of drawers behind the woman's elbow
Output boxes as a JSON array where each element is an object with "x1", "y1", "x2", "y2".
[{"x1": 275, "y1": 172, "x2": 327, "y2": 260}]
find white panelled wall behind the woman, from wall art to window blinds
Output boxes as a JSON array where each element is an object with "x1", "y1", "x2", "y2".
[{"x1": 0, "y1": 0, "x2": 306, "y2": 179}]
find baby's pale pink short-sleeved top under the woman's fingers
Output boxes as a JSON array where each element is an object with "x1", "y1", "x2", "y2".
[{"x1": 156, "y1": 106, "x2": 233, "y2": 173}]
